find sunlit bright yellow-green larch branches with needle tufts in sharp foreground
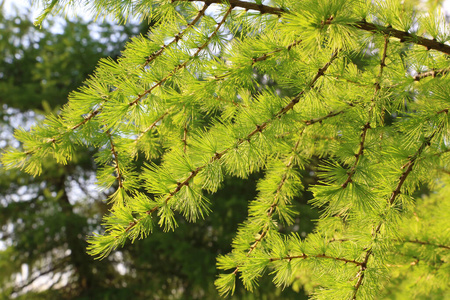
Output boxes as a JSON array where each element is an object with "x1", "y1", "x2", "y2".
[{"x1": 3, "y1": 0, "x2": 450, "y2": 299}]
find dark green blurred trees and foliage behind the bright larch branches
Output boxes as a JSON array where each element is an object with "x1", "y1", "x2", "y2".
[{"x1": 0, "y1": 0, "x2": 442, "y2": 300}]
